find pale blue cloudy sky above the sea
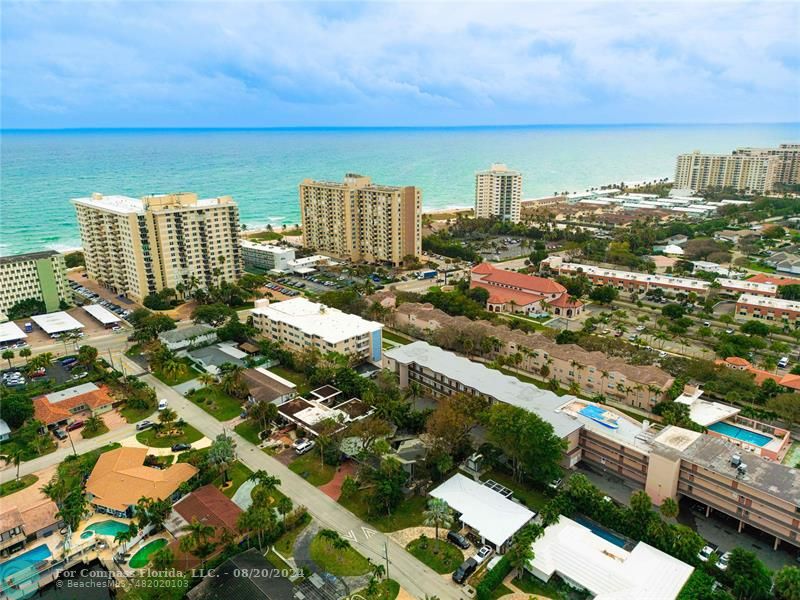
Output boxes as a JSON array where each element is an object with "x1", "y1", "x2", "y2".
[{"x1": 0, "y1": 0, "x2": 800, "y2": 128}]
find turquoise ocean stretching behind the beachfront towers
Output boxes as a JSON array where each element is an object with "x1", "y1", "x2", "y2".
[{"x1": 0, "y1": 124, "x2": 800, "y2": 255}]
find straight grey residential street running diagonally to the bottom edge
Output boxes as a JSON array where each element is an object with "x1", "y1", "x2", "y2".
[{"x1": 144, "y1": 375, "x2": 462, "y2": 600}]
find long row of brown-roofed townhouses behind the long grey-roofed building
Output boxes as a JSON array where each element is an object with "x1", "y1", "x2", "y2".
[{"x1": 392, "y1": 302, "x2": 674, "y2": 411}]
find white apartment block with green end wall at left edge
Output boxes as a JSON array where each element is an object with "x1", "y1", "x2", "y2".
[{"x1": 0, "y1": 250, "x2": 72, "y2": 313}]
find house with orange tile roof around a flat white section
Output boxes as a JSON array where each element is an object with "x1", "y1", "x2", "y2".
[{"x1": 33, "y1": 383, "x2": 115, "y2": 429}]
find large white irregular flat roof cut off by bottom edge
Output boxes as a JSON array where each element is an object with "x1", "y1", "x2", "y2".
[{"x1": 529, "y1": 516, "x2": 694, "y2": 600}]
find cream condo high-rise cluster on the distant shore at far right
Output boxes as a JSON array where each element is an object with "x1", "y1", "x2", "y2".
[{"x1": 675, "y1": 144, "x2": 800, "y2": 193}]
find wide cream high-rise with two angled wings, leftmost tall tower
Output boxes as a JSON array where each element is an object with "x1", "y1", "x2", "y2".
[{"x1": 72, "y1": 192, "x2": 242, "y2": 302}]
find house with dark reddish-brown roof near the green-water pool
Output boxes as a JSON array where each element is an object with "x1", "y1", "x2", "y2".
[{"x1": 165, "y1": 484, "x2": 242, "y2": 569}]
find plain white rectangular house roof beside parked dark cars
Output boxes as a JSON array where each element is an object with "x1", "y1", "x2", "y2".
[{"x1": 430, "y1": 473, "x2": 535, "y2": 546}]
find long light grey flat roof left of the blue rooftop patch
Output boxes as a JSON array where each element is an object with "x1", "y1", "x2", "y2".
[{"x1": 384, "y1": 341, "x2": 581, "y2": 438}]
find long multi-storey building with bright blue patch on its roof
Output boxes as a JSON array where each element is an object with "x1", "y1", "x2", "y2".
[{"x1": 385, "y1": 342, "x2": 800, "y2": 547}]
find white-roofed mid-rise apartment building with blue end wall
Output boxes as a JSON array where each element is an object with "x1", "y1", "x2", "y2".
[{"x1": 252, "y1": 297, "x2": 383, "y2": 363}]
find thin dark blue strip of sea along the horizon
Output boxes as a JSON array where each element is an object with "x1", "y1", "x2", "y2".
[{"x1": 0, "y1": 121, "x2": 800, "y2": 134}]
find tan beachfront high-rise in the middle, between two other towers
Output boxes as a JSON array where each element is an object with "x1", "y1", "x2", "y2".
[{"x1": 300, "y1": 173, "x2": 422, "y2": 266}]
